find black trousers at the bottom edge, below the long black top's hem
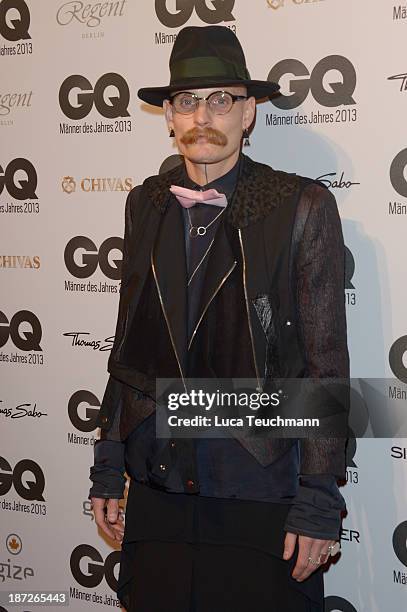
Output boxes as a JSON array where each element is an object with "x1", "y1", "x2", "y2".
[{"x1": 127, "y1": 541, "x2": 323, "y2": 612}]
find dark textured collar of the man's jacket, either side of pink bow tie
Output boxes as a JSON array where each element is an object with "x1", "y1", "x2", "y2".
[{"x1": 144, "y1": 153, "x2": 299, "y2": 228}]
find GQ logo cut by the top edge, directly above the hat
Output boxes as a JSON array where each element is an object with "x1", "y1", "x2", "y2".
[{"x1": 155, "y1": 0, "x2": 235, "y2": 28}]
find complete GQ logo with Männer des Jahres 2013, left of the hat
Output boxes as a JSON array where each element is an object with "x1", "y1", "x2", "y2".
[{"x1": 59, "y1": 72, "x2": 132, "y2": 134}]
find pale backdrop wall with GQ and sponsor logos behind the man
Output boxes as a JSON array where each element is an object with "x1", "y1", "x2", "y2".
[{"x1": 0, "y1": 0, "x2": 407, "y2": 612}]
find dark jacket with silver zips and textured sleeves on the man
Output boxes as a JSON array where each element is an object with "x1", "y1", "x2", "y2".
[{"x1": 89, "y1": 156, "x2": 349, "y2": 536}]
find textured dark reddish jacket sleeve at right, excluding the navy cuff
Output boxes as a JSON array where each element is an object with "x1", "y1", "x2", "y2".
[{"x1": 296, "y1": 183, "x2": 349, "y2": 478}]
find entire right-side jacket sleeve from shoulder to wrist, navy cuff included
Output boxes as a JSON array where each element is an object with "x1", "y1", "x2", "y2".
[{"x1": 285, "y1": 183, "x2": 349, "y2": 539}]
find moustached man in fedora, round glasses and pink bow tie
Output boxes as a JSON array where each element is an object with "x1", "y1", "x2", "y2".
[{"x1": 89, "y1": 26, "x2": 349, "y2": 612}]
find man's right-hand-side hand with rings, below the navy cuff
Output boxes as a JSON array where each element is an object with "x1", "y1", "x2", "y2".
[{"x1": 283, "y1": 532, "x2": 335, "y2": 582}]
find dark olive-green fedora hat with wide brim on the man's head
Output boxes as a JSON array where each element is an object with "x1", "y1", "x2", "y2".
[{"x1": 137, "y1": 26, "x2": 280, "y2": 106}]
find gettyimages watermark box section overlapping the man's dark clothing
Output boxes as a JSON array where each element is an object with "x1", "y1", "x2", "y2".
[{"x1": 156, "y1": 378, "x2": 349, "y2": 438}]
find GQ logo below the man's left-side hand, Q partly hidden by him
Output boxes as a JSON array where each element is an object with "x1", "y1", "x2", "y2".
[{"x1": 69, "y1": 544, "x2": 120, "y2": 591}]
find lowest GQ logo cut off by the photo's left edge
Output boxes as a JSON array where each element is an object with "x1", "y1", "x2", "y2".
[{"x1": 0, "y1": 457, "x2": 45, "y2": 501}]
